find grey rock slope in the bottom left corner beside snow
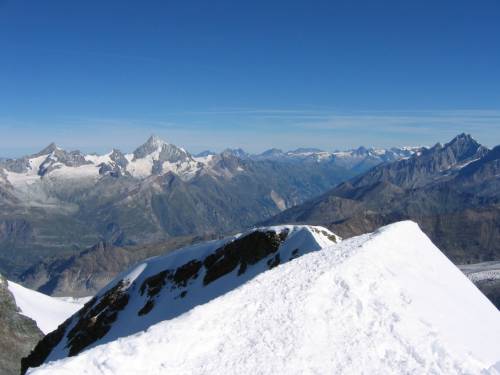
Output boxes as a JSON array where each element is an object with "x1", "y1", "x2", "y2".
[{"x1": 0, "y1": 275, "x2": 43, "y2": 375}]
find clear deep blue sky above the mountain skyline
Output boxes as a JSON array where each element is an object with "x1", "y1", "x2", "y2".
[{"x1": 0, "y1": 0, "x2": 500, "y2": 156}]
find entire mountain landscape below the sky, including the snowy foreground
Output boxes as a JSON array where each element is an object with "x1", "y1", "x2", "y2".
[{"x1": 0, "y1": 134, "x2": 500, "y2": 375}]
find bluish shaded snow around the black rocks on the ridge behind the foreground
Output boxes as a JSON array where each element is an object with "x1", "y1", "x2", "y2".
[{"x1": 38, "y1": 225, "x2": 340, "y2": 361}]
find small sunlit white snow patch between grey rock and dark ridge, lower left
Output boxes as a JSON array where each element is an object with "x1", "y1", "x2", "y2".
[{"x1": 8, "y1": 281, "x2": 85, "y2": 334}]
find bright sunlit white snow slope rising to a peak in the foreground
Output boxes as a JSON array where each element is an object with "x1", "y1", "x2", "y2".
[{"x1": 30, "y1": 222, "x2": 500, "y2": 375}]
